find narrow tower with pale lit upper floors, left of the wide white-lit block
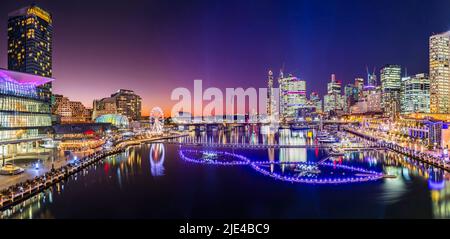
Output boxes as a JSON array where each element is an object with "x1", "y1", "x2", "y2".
[{"x1": 380, "y1": 65, "x2": 402, "y2": 118}]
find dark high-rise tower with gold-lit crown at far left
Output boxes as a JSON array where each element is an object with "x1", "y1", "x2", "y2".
[{"x1": 8, "y1": 4, "x2": 53, "y2": 102}]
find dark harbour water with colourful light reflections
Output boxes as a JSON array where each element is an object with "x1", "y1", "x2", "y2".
[{"x1": 2, "y1": 129, "x2": 450, "y2": 219}]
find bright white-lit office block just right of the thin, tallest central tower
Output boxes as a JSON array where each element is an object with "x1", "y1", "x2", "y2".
[{"x1": 280, "y1": 75, "x2": 307, "y2": 121}]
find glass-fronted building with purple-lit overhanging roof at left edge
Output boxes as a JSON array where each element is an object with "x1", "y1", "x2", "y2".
[{"x1": 0, "y1": 69, "x2": 53, "y2": 157}]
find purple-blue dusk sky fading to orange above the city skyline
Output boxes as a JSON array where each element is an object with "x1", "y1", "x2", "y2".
[{"x1": 0, "y1": 0, "x2": 450, "y2": 114}]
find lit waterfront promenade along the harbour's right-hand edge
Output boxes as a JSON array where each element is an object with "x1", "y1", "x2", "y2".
[{"x1": 344, "y1": 127, "x2": 450, "y2": 171}]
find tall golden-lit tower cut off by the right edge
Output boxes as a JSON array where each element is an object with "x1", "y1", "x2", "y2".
[{"x1": 430, "y1": 32, "x2": 450, "y2": 114}]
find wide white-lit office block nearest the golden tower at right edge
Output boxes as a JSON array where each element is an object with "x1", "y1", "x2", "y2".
[{"x1": 401, "y1": 74, "x2": 430, "y2": 114}]
